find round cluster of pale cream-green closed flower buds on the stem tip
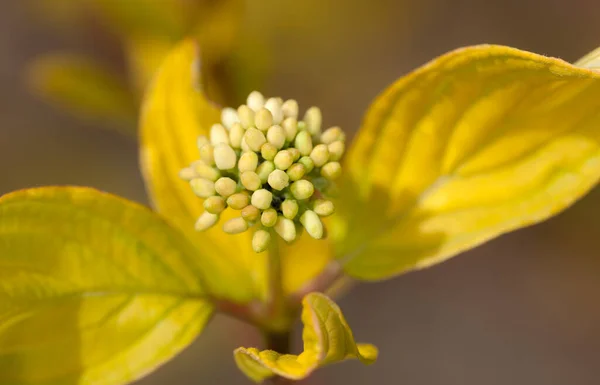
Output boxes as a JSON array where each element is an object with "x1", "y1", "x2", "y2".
[{"x1": 180, "y1": 91, "x2": 345, "y2": 253}]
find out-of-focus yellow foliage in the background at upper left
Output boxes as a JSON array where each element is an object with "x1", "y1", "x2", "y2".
[{"x1": 27, "y1": 0, "x2": 258, "y2": 135}]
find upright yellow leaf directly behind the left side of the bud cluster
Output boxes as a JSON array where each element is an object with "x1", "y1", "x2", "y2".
[{"x1": 140, "y1": 41, "x2": 267, "y2": 302}]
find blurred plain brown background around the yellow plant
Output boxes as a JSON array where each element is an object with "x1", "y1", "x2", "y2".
[{"x1": 0, "y1": 0, "x2": 600, "y2": 385}]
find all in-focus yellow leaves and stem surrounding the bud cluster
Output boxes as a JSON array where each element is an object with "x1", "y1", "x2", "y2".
[{"x1": 0, "y1": 36, "x2": 600, "y2": 385}]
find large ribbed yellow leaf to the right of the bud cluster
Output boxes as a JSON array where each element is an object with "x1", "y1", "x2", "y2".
[{"x1": 332, "y1": 45, "x2": 600, "y2": 279}]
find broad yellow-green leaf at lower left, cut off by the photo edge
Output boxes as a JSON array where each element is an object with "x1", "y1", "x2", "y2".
[{"x1": 0, "y1": 187, "x2": 213, "y2": 385}]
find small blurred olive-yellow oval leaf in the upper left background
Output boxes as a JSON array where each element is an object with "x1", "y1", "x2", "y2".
[{"x1": 27, "y1": 54, "x2": 137, "y2": 134}]
